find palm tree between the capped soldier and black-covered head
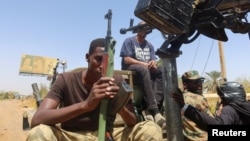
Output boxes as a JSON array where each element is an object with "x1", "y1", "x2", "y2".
[{"x1": 203, "y1": 71, "x2": 223, "y2": 93}]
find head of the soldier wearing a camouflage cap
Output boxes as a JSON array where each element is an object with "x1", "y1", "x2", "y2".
[{"x1": 181, "y1": 70, "x2": 205, "y2": 94}]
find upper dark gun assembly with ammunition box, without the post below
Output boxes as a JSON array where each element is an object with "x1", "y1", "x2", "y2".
[{"x1": 128, "y1": 0, "x2": 250, "y2": 55}]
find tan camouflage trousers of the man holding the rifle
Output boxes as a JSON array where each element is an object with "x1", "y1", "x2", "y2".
[{"x1": 26, "y1": 121, "x2": 162, "y2": 141}]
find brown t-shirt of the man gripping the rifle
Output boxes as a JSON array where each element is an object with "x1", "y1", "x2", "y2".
[{"x1": 46, "y1": 71, "x2": 131, "y2": 131}]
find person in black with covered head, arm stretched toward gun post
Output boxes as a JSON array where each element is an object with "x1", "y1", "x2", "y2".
[{"x1": 172, "y1": 82, "x2": 250, "y2": 131}]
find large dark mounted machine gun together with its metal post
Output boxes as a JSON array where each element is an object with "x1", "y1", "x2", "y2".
[{"x1": 120, "y1": 0, "x2": 250, "y2": 141}]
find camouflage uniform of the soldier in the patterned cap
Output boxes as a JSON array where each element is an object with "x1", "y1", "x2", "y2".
[{"x1": 182, "y1": 92, "x2": 213, "y2": 141}]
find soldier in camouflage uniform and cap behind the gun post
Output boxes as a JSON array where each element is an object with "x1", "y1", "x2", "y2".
[{"x1": 181, "y1": 70, "x2": 213, "y2": 141}]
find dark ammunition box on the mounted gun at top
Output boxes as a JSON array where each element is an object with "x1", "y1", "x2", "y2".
[{"x1": 134, "y1": 0, "x2": 193, "y2": 34}]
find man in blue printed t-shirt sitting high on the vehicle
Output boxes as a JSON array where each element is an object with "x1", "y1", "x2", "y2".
[{"x1": 120, "y1": 22, "x2": 165, "y2": 126}]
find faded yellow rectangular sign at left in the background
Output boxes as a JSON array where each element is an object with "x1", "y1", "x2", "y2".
[{"x1": 19, "y1": 55, "x2": 58, "y2": 75}]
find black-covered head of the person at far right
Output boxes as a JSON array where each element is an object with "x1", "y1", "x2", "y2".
[{"x1": 217, "y1": 82, "x2": 246, "y2": 105}]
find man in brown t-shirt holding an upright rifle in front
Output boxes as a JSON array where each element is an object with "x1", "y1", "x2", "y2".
[{"x1": 27, "y1": 38, "x2": 162, "y2": 141}]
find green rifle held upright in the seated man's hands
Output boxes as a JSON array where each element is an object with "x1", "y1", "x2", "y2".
[{"x1": 98, "y1": 9, "x2": 116, "y2": 141}]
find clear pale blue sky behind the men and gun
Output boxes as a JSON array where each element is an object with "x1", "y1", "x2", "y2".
[{"x1": 0, "y1": 0, "x2": 250, "y2": 95}]
